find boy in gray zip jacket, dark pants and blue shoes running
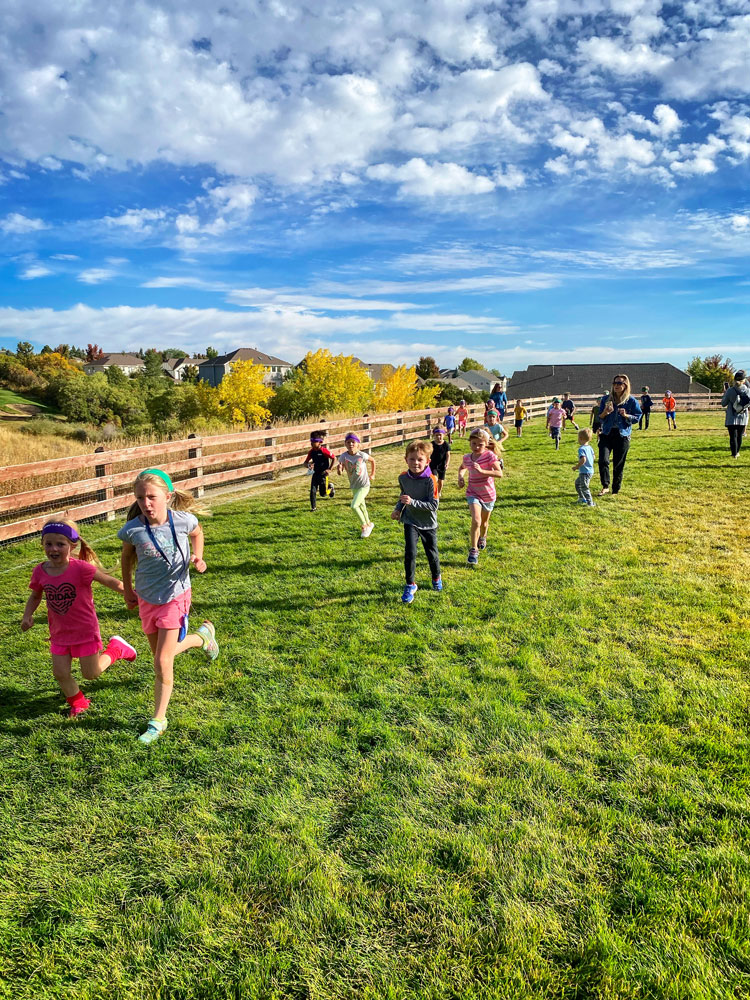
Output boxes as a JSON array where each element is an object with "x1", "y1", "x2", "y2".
[{"x1": 391, "y1": 441, "x2": 443, "y2": 604}]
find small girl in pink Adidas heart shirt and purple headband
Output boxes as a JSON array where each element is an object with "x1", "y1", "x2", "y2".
[{"x1": 21, "y1": 517, "x2": 136, "y2": 718}]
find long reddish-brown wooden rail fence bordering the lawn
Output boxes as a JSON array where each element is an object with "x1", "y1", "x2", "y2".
[{"x1": 0, "y1": 394, "x2": 720, "y2": 543}]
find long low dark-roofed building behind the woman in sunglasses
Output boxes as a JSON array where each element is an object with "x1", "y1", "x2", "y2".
[{"x1": 507, "y1": 361, "x2": 708, "y2": 399}]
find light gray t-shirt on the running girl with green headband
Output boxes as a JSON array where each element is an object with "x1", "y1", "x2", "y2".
[{"x1": 117, "y1": 510, "x2": 198, "y2": 604}]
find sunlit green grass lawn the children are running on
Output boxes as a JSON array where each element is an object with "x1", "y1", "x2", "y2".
[{"x1": 0, "y1": 414, "x2": 750, "y2": 1000}]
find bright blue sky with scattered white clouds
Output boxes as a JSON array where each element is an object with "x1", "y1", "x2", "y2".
[{"x1": 0, "y1": 0, "x2": 750, "y2": 374}]
